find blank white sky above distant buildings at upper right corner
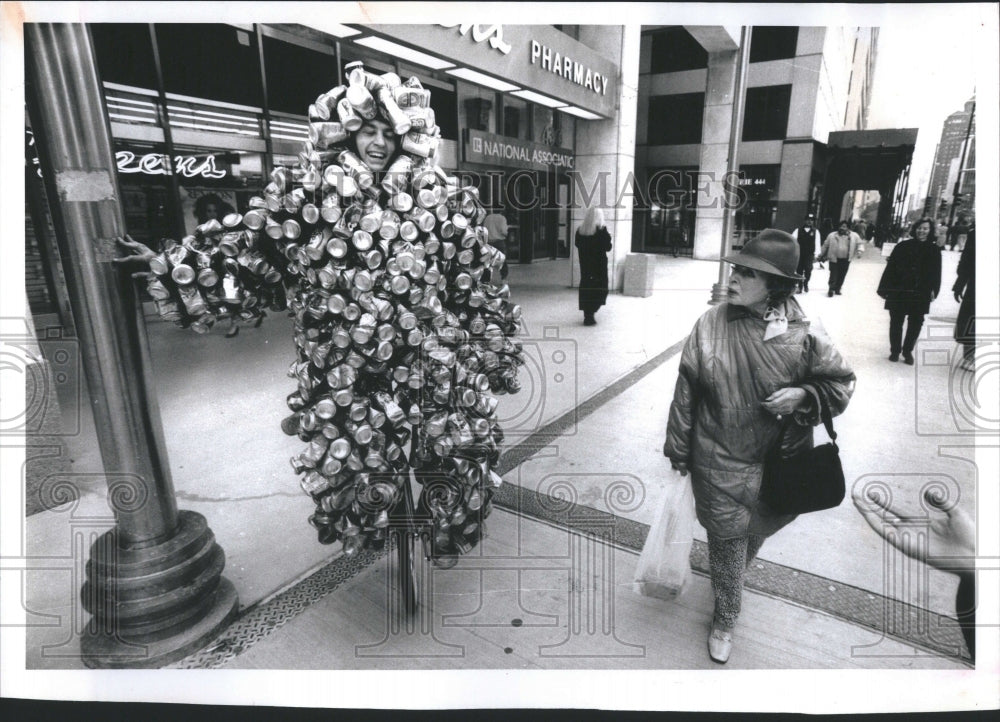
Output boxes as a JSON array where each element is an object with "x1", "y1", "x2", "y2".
[{"x1": 868, "y1": 6, "x2": 981, "y2": 192}]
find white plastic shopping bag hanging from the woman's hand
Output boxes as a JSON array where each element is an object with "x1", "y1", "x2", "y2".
[{"x1": 635, "y1": 476, "x2": 694, "y2": 599}]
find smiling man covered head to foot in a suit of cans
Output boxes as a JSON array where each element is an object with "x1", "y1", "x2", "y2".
[{"x1": 119, "y1": 63, "x2": 523, "y2": 566}]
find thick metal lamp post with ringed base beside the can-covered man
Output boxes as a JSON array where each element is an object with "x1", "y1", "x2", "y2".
[{"x1": 24, "y1": 23, "x2": 238, "y2": 667}]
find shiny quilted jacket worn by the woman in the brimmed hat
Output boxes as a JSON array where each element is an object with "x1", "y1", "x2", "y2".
[{"x1": 664, "y1": 298, "x2": 855, "y2": 539}]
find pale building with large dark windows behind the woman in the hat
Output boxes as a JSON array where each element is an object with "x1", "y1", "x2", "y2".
[{"x1": 633, "y1": 26, "x2": 878, "y2": 258}]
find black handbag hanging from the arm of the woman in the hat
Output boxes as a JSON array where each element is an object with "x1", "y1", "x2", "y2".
[{"x1": 760, "y1": 391, "x2": 846, "y2": 514}]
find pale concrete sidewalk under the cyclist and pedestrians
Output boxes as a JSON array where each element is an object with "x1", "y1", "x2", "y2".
[{"x1": 19, "y1": 249, "x2": 975, "y2": 668}]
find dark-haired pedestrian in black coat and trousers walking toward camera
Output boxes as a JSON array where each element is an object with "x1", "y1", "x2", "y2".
[{"x1": 878, "y1": 218, "x2": 941, "y2": 366}]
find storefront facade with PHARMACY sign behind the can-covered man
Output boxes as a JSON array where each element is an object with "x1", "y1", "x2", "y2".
[{"x1": 25, "y1": 22, "x2": 638, "y2": 320}]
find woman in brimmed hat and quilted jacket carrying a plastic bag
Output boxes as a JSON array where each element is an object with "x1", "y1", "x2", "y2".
[{"x1": 663, "y1": 229, "x2": 855, "y2": 663}]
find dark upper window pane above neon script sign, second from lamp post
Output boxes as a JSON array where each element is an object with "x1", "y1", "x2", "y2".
[{"x1": 156, "y1": 24, "x2": 262, "y2": 107}]
